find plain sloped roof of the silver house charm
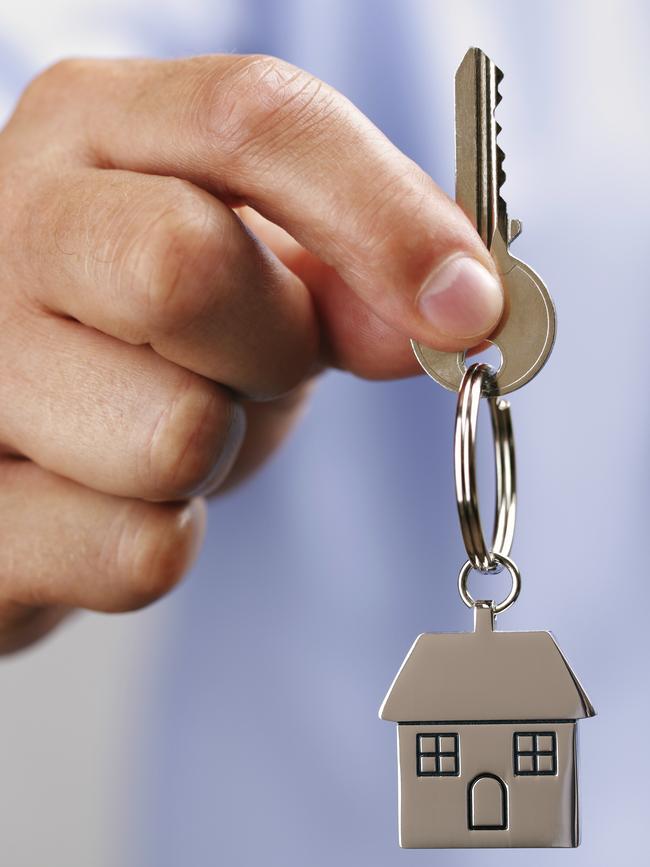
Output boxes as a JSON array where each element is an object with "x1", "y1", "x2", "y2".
[{"x1": 379, "y1": 603, "x2": 596, "y2": 722}]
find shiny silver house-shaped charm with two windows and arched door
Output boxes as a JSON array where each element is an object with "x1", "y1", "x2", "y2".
[{"x1": 379, "y1": 602, "x2": 595, "y2": 849}]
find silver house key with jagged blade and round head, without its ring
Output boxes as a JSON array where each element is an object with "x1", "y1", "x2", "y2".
[{"x1": 411, "y1": 48, "x2": 556, "y2": 395}]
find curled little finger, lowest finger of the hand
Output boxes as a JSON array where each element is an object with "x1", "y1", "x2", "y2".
[{"x1": 0, "y1": 459, "x2": 205, "y2": 651}]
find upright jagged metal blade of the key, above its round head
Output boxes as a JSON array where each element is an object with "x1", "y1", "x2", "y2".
[{"x1": 456, "y1": 48, "x2": 508, "y2": 249}]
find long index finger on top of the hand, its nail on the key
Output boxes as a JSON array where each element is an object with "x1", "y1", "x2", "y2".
[{"x1": 12, "y1": 55, "x2": 503, "y2": 349}]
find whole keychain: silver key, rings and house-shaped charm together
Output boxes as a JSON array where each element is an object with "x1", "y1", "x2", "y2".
[{"x1": 379, "y1": 48, "x2": 595, "y2": 849}]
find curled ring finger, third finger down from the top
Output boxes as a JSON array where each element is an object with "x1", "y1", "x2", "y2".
[{"x1": 0, "y1": 311, "x2": 245, "y2": 500}]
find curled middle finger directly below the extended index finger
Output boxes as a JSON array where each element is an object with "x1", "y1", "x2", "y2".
[{"x1": 13, "y1": 169, "x2": 318, "y2": 398}]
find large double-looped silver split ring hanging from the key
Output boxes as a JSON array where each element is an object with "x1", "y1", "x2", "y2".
[{"x1": 454, "y1": 364, "x2": 517, "y2": 572}]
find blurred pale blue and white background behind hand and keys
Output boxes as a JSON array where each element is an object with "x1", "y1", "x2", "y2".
[{"x1": 0, "y1": 0, "x2": 650, "y2": 867}]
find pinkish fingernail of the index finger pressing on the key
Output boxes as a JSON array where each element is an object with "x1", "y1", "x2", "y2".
[{"x1": 417, "y1": 255, "x2": 503, "y2": 339}]
